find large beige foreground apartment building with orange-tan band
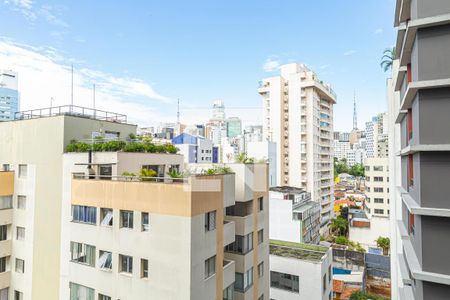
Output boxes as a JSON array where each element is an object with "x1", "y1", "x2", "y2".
[{"x1": 0, "y1": 108, "x2": 269, "y2": 300}]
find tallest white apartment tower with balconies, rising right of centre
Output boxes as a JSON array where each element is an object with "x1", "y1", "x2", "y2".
[{"x1": 258, "y1": 63, "x2": 336, "y2": 232}]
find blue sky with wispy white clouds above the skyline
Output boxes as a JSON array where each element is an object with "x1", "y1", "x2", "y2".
[{"x1": 0, "y1": 0, "x2": 395, "y2": 130}]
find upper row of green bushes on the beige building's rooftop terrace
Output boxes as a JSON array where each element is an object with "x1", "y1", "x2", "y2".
[{"x1": 66, "y1": 137, "x2": 178, "y2": 154}]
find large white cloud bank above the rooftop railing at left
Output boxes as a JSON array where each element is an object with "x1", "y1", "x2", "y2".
[{"x1": 0, "y1": 40, "x2": 172, "y2": 126}]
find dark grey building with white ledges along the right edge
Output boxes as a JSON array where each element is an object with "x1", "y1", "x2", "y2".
[{"x1": 388, "y1": 0, "x2": 450, "y2": 300}]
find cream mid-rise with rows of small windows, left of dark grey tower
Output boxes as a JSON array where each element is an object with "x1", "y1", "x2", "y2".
[{"x1": 364, "y1": 157, "x2": 390, "y2": 217}]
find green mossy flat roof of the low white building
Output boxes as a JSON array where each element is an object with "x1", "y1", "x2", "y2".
[{"x1": 270, "y1": 240, "x2": 328, "y2": 262}]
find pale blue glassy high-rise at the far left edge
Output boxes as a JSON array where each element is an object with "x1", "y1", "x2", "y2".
[{"x1": 0, "y1": 70, "x2": 19, "y2": 122}]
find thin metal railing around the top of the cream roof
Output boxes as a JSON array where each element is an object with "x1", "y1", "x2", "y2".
[{"x1": 14, "y1": 105, "x2": 127, "y2": 123}]
